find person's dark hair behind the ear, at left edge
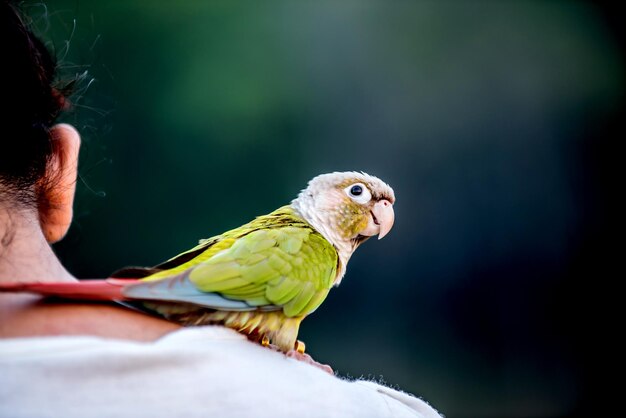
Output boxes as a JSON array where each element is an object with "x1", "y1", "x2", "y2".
[{"x1": 0, "y1": 0, "x2": 71, "y2": 204}]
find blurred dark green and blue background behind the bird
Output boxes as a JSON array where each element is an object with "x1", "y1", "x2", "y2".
[{"x1": 25, "y1": 0, "x2": 625, "y2": 418}]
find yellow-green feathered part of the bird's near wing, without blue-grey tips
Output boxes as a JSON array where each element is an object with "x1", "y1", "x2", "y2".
[{"x1": 189, "y1": 226, "x2": 337, "y2": 316}]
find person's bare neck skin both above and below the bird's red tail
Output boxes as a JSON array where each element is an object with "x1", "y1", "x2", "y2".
[{"x1": 0, "y1": 205, "x2": 180, "y2": 341}]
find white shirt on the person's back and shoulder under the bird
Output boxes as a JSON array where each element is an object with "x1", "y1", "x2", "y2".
[{"x1": 0, "y1": 326, "x2": 440, "y2": 418}]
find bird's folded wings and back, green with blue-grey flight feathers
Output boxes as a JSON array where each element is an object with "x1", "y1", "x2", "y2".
[{"x1": 126, "y1": 206, "x2": 338, "y2": 316}]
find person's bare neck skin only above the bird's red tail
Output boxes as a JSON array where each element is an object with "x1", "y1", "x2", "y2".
[{"x1": 0, "y1": 203, "x2": 76, "y2": 282}]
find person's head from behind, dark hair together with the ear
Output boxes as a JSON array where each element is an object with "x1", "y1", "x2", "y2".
[{"x1": 0, "y1": 0, "x2": 80, "y2": 243}]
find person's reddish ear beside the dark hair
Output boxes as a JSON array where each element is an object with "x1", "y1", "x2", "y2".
[{"x1": 38, "y1": 124, "x2": 80, "y2": 244}]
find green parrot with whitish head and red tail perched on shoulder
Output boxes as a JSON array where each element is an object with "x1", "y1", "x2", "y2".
[{"x1": 0, "y1": 171, "x2": 395, "y2": 360}]
